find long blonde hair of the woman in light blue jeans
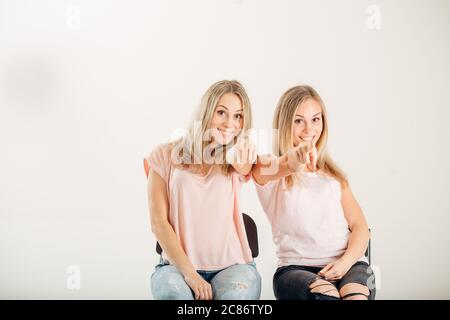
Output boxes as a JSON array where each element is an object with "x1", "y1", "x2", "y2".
[{"x1": 171, "y1": 80, "x2": 252, "y2": 175}]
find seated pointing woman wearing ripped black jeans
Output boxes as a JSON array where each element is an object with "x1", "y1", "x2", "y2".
[{"x1": 253, "y1": 86, "x2": 375, "y2": 300}]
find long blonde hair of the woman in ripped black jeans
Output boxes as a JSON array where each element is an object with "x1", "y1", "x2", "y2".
[{"x1": 273, "y1": 85, "x2": 348, "y2": 188}]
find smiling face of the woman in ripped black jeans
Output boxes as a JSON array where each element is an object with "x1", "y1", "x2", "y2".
[{"x1": 292, "y1": 98, "x2": 323, "y2": 147}]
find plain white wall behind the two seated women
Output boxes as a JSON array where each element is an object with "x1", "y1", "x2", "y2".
[{"x1": 0, "y1": 0, "x2": 450, "y2": 299}]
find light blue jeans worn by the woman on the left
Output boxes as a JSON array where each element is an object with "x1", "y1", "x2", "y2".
[{"x1": 151, "y1": 261, "x2": 261, "y2": 300}]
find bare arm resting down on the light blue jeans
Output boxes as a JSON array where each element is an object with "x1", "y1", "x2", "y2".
[{"x1": 147, "y1": 170, "x2": 212, "y2": 300}]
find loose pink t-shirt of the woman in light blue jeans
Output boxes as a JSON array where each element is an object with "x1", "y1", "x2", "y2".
[{"x1": 144, "y1": 144, "x2": 252, "y2": 270}]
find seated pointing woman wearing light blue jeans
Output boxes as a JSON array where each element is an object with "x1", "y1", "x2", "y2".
[{"x1": 144, "y1": 81, "x2": 261, "y2": 300}]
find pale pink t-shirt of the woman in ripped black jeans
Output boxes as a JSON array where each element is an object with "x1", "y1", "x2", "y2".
[{"x1": 254, "y1": 172, "x2": 367, "y2": 267}]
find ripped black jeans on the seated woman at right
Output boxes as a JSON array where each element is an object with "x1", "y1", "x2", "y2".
[{"x1": 273, "y1": 261, "x2": 376, "y2": 300}]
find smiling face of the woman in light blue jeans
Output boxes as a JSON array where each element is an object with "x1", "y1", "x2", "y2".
[{"x1": 210, "y1": 93, "x2": 244, "y2": 145}]
